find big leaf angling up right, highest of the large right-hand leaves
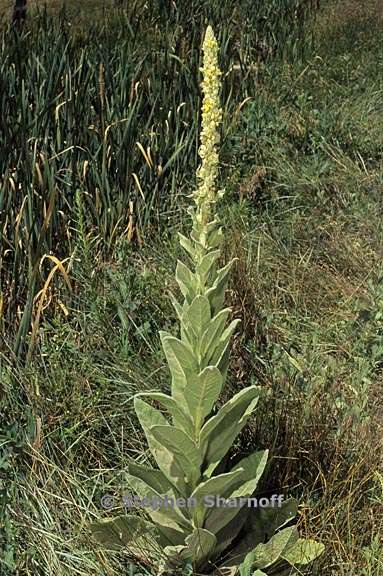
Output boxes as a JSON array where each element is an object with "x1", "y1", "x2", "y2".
[{"x1": 200, "y1": 386, "x2": 261, "y2": 467}]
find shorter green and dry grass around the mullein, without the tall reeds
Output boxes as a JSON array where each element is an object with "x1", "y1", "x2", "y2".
[{"x1": 0, "y1": 2, "x2": 383, "y2": 576}]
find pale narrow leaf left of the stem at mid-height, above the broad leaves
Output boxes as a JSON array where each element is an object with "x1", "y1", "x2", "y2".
[{"x1": 160, "y1": 331, "x2": 199, "y2": 408}]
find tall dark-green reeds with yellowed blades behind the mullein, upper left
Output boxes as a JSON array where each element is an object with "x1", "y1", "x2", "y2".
[{"x1": 0, "y1": 0, "x2": 318, "y2": 358}]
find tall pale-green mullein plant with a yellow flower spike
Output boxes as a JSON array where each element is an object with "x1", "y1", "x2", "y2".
[{"x1": 92, "y1": 27, "x2": 322, "y2": 576}]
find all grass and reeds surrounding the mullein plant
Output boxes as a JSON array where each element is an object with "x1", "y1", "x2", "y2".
[{"x1": 0, "y1": 0, "x2": 383, "y2": 576}]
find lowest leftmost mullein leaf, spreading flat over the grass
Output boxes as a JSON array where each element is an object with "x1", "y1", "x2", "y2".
[{"x1": 90, "y1": 515, "x2": 158, "y2": 550}]
